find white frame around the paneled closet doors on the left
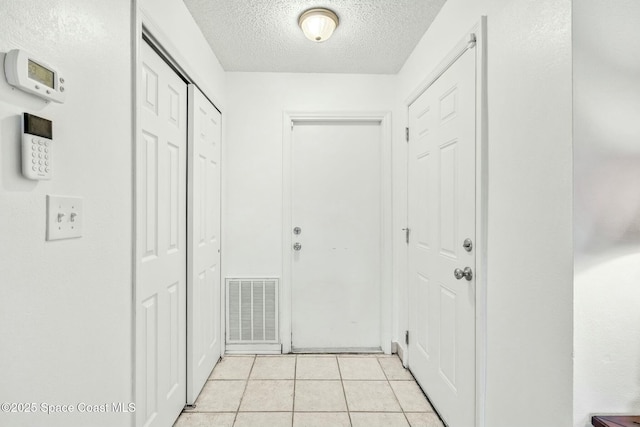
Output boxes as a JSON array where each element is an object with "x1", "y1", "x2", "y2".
[{"x1": 130, "y1": 7, "x2": 225, "y2": 426}]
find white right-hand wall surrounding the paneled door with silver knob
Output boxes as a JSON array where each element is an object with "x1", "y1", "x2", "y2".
[{"x1": 394, "y1": 0, "x2": 573, "y2": 427}]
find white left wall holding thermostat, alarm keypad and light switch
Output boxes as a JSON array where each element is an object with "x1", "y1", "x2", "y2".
[{"x1": 0, "y1": 0, "x2": 132, "y2": 427}]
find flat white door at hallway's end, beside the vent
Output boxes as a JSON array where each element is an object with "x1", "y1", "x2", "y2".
[{"x1": 291, "y1": 121, "x2": 382, "y2": 351}]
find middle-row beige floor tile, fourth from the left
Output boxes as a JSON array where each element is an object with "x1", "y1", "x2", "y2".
[{"x1": 343, "y1": 381, "x2": 402, "y2": 412}]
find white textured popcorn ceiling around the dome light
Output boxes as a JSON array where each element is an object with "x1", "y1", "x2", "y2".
[{"x1": 184, "y1": 0, "x2": 446, "y2": 74}]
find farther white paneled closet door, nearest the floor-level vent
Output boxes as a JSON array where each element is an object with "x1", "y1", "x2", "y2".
[{"x1": 187, "y1": 85, "x2": 222, "y2": 404}]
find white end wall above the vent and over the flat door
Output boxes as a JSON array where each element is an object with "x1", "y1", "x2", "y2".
[{"x1": 222, "y1": 72, "x2": 394, "y2": 277}]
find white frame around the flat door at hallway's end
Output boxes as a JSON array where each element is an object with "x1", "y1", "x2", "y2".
[{"x1": 280, "y1": 111, "x2": 393, "y2": 353}]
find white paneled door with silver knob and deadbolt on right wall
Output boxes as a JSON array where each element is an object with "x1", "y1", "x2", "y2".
[{"x1": 409, "y1": 45, "x2": 476, "y2": 427}]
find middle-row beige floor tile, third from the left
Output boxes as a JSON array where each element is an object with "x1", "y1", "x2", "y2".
[{"x1": 294, "y1": 380, "x2": 347, "y2": 412}]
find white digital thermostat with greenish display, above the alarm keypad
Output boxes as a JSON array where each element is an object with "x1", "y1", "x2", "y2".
[{"x1": 4, "y1": 49, "x2": 65, "y2": 103}]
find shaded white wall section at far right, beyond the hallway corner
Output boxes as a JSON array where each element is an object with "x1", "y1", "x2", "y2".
[{"x1": 573, "y1": 0, "x2": 640, "y2": 427}]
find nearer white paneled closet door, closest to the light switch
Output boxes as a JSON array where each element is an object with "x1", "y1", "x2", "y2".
[{"x1": 135, "y1": 42, "x2": 187, "y2": 426}]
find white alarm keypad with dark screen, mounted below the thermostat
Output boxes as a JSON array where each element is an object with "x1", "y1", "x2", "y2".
[{"x1": 22, "y1": 113, "x2": 53, "y2": 180}]
